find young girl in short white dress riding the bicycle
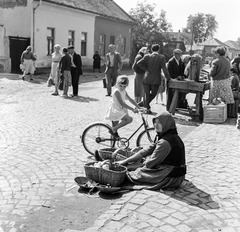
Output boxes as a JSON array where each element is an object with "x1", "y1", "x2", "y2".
[{"x1": 105, "y1": 76, "x2": 140, "y2": 138}]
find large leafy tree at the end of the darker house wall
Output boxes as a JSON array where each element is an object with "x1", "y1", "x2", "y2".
[{"x1": 129, "y1": 1, "x2": 172, "y2": 63}]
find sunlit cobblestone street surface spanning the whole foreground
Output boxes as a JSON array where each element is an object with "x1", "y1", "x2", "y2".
[{"x1": 0, "y1": 75, "x2": 240, "y2": 232}]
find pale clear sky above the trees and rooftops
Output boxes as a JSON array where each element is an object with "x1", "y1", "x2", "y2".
[{"x1": 114, "y1": 0, "x2": 240, "y2": 42}]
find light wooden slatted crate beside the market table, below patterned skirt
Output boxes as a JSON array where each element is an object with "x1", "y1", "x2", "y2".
[{"x1": 203, "y1": 104, "x2": 227, "y2": 123}]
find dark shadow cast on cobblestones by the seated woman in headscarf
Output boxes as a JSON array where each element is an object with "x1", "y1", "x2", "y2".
[{"x1": 164, "y1": 180, "x2": 220, "y2": 210}]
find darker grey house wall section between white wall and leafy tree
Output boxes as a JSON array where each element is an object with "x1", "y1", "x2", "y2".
[{"x1": 94, "y1": 17, "x2": 132, "y2": 60}]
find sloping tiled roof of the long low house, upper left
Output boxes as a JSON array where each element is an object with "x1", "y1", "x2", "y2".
[{"x1": 43, "y1": 0, "x2": 134, "y2": 23}]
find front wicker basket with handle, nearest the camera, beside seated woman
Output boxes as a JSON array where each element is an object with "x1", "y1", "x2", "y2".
[{"x1": 84, "y1": 162, "x2": 127, "y2": 187}]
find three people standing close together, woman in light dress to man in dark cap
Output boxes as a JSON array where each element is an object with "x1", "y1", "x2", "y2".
[{"x1": 48, "y1": 44, "x2": 82, "y2": 97}]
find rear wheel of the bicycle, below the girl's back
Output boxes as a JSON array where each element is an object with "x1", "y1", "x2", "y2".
[{"x1": 81, "y1": 122, "x2": 115, "y2": 155}]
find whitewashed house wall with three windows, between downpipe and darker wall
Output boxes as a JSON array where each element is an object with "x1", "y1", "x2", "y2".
[{"x1": 34, "y1": 2, "x2": 95, "y2": 67}]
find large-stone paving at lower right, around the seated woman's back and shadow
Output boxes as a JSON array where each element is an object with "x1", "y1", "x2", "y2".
[{"x1": 80, "y1": 120, "x2": 240, "y2": 232}]
